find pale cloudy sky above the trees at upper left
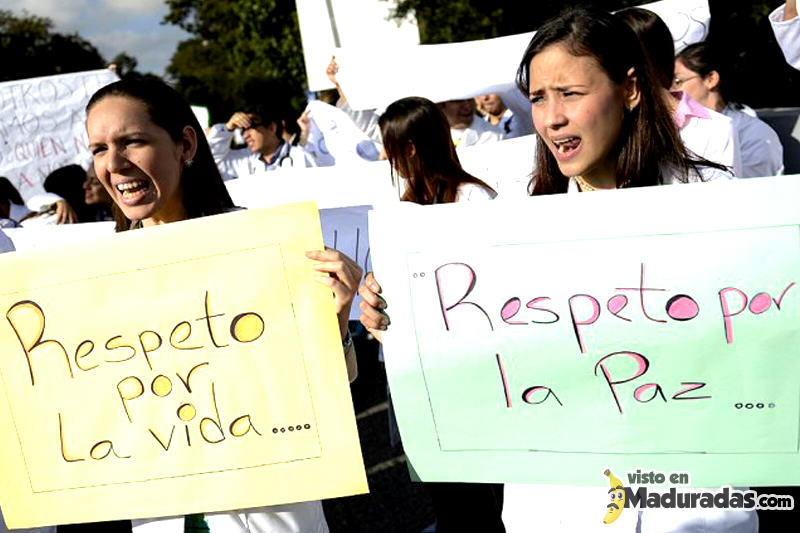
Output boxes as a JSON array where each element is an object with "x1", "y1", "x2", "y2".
[{"x1": 2, "y1": 0, "x2": 189, "y2": 75}]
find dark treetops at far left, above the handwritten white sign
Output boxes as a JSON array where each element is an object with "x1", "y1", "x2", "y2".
[{"x1": 0, "y1": 10, "x2": 106, "y2": 81}]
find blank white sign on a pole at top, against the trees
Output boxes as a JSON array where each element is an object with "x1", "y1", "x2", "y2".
[{"x1": 295, "y1": 0, "x2": 419, "y2": 91}]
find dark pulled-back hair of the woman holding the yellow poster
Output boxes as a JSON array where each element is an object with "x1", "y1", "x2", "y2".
[{"x1": 86, "y1": 76, "x2": 233, "y2": 231}]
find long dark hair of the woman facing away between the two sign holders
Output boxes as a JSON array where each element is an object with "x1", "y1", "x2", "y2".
[{"x1": 378, "y1": 96, "x2": 495, "y2": 205}]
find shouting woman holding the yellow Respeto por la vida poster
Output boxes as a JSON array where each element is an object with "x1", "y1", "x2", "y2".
[{"x1": 86, "y1": 79, "x2": 361, "y2": 533}]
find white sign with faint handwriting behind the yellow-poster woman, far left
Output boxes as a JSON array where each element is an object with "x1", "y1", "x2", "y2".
[{"x1": 0, "y1": 70, "x2": 117, "y2": 199}]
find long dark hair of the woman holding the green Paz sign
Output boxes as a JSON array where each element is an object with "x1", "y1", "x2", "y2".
[{"x1": 517, "y1": 8, "x2": 724, "y2": 195}]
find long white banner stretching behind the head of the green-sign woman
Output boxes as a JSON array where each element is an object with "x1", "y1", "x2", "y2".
[{"x1": 336, "y1": 0, "x2": 711, "y2": 109}]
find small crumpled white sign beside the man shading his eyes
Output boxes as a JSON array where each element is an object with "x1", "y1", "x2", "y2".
[{"x1": 305, "y1": 100, "x2": 381, "y2": 166}]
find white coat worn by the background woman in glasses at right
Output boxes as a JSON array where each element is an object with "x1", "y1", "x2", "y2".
[{"x1": 722, "y1": 105, "x2": 783, "y2": 178}]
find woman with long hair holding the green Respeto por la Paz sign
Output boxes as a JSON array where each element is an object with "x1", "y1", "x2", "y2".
[{"x1": 359, "y1": 5, "x2": 740, "y2": 531}]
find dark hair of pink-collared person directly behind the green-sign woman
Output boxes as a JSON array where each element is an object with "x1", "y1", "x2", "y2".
[{"x1": 617, "y1": 7, "x2": 675, "y2": 89}]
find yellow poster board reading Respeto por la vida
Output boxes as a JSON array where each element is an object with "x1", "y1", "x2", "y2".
[{"x1": 0, "y1": 203, "x2": 367, "y2": 527}]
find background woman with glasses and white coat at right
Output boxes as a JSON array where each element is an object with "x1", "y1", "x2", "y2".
[{"x1": 675, "y1": 42, "x2": 783, "y2": 178}]
